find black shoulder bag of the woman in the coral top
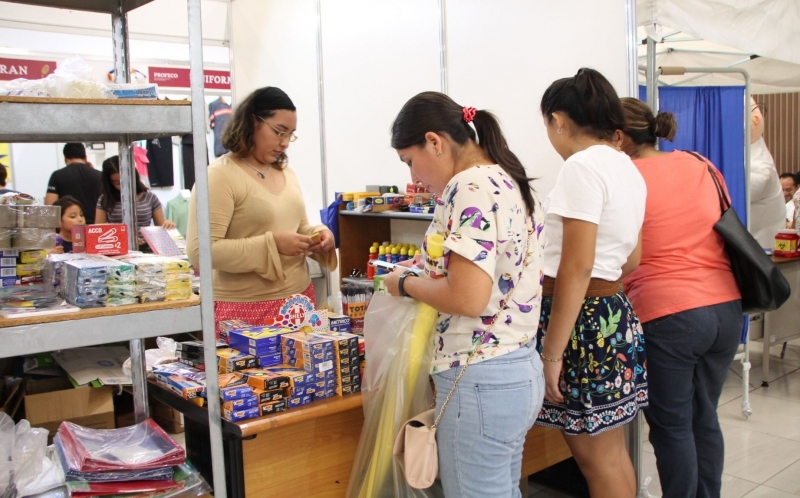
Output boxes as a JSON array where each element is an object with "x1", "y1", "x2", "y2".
[{"x1": 686, "y1": 151, "x2": 791, "y2": 314}]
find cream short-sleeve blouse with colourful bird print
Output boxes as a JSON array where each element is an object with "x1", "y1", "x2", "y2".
[{"x1": 427, "y1": 165, "x2": 544, "y2": 373}]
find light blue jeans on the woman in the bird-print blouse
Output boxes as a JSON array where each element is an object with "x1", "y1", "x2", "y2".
[{"x1": 433, "y1": 343, "x2": 544, "y2": 498}]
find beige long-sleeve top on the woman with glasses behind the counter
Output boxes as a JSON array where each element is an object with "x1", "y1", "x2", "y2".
[{"x1": 186, "y1": 156, "x2": 337, "y2": 302}]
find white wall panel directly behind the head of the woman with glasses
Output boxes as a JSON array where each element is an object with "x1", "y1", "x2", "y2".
[{"x1": 231, "y1": 0, "x2": 322, "y2": 223}]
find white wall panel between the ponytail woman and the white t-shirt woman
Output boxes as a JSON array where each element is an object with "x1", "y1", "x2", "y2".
[{"x1": 447, "y1": 0, "x2": 627, "y2": 196}]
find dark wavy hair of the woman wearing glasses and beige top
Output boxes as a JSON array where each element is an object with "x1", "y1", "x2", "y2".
[{"x1": 222, "y1": 86, "x2": 297, "y2": 167}]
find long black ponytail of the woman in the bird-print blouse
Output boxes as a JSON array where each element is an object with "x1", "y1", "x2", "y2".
[{"x1": 470, "y1": 110, "x2": 536, "y2": 215}]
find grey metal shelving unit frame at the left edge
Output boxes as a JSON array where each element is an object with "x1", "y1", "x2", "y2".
[{"x1": 0, "y1": 0, "x2": 227, "y2": 498}]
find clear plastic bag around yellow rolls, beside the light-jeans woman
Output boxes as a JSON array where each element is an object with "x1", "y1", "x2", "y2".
[{"x1": 347, "y1": 294, "x2": 444, "y2": 498}]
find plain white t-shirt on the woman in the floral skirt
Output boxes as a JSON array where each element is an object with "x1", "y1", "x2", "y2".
[{"x1": 544, "y1": 145, "x2": 647, "y2": 281}]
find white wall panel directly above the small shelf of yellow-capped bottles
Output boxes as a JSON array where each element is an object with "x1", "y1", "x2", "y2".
[{"x1": 322, "y1": 0, "x2": 440, "y2": 198}]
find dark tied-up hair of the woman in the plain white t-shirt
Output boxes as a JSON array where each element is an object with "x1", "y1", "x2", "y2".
[{"x1": 540, "y1": 67, "x2": 625, "y2": 140}]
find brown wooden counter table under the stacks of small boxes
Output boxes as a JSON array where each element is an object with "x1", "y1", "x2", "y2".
[{"x1": 150, "y1": 382, "x2": 570, "y2": 498}]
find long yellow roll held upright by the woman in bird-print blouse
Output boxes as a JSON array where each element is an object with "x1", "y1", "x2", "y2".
[{"x1": 359, "y1": 234, "x2": 444, "y2": 498}]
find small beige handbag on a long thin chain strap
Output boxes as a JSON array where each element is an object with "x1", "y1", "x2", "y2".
[{"x1": 392, "y1": 227, "x2": 533, "y2": 489}]
